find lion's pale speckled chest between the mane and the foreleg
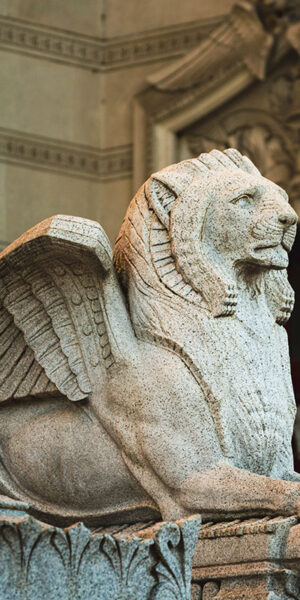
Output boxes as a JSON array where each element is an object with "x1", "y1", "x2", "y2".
[{"x1": 192, "y1": 319, "x2": 293, "y2": 475}]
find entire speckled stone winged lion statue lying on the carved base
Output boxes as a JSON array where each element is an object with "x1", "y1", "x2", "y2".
[{"x1": 0, "y1": 149, "x2": 300, "y2": 528}]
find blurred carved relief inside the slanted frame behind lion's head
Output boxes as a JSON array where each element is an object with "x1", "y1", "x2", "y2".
[{"x1": 179, "y1": 59, "x2": 300, "y2": 213}]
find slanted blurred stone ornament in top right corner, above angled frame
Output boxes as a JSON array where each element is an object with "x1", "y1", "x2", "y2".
[{"x1": 147, "y1": 0, "x2": 300, "y2": 93}]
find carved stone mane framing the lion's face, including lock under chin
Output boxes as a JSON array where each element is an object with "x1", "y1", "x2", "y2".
[{"x1": 114, "y1": 148, "x2": 294, "y2": 334}]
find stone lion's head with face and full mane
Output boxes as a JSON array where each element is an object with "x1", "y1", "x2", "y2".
[{"x1": 115, "y1": 149, "x2": 297, "y2": 323}]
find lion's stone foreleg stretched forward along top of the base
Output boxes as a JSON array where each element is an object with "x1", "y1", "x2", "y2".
[{"x1": 128, "y1": 420, "x2": 300, "y2": 520}]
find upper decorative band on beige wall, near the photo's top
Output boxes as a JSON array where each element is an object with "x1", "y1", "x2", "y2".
[{"x1": 0, "y1": 16, "x2": 221, "y2": 71}]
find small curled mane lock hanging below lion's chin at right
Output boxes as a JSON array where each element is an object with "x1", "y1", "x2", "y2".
[{"x1": 265, "y1": 269, "x2": 295, "y2": 325}]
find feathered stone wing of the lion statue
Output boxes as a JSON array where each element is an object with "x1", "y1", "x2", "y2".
[{"x1": 0, "y1": 215, "x2": 134, "y2": 402}]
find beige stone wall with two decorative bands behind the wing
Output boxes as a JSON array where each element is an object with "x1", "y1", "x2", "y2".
[{"x1": 0, "y1": 0, "x2": 232, "y2": 246}]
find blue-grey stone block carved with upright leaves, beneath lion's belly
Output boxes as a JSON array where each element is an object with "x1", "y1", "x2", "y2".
[{"x1": 0, "y1": 498, "x2": 201, "y2": 600}]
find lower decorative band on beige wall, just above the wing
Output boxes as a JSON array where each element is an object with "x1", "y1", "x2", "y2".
[{"x1": 0, "y1": 127, "x2": 132, "y2": 180}]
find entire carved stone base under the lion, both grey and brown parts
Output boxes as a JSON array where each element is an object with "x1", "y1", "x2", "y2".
[{"x1": 0, "y1": 508, "x2": 300, "y2": 600}]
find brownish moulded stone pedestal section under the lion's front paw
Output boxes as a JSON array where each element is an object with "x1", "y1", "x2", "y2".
[{"x1": 192, "y1": 517, "x2": 300, "y2": 600}]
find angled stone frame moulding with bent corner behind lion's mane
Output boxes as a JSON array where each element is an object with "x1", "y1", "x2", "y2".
[{"x1": 133, "y1": 60, "x2": 254, "y2": 189}]
